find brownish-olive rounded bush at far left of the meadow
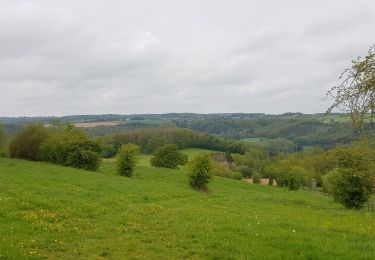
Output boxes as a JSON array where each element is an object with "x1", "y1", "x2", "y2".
[{"x1": 9, "y1": 124, "x2": 49, "y2": 161}]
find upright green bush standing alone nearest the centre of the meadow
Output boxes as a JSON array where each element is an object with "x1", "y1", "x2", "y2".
[{"x1": 188, "y1": 154, "x2": 213, "y2": 191}]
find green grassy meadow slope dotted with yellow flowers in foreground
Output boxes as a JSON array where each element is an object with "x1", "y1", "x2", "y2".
[{"x1": 0, "y1": 155, "x2": 375, "y2": 259}]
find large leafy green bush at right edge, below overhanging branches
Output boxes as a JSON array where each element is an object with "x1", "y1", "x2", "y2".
[{"x1": 324, "y1": 144, "x2": 375, "y2": 209}]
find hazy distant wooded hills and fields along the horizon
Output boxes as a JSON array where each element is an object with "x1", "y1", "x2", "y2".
[{"x1": 0, "y1": 113, "x2": 375, "y2": 154}]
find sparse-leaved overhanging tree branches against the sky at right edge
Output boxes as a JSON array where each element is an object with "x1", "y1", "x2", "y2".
[{"x1": 327, "y1": 45, "x2": 375, "y2": 135}]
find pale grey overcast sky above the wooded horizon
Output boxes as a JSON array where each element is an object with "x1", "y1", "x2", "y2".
[{"x1": 0, "y1": 0, "x2": 375, "y2": 116}]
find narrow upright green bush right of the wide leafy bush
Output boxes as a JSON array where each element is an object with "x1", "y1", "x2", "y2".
[{"x1": 116, "y1": 144, "x2": 139, "y2": 177}]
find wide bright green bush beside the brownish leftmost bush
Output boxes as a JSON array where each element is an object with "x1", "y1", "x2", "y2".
[{"x1": 40, "y1": 126, "x2": 101, "y2": 171}]
